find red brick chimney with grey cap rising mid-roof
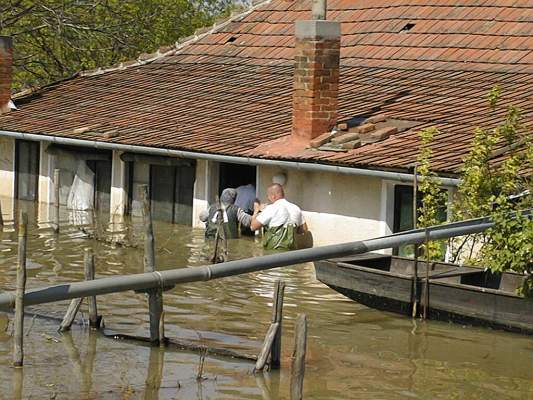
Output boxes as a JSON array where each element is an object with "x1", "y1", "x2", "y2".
[{"x1": 292, "y1": 0, "x2": 341, "y2": 141}]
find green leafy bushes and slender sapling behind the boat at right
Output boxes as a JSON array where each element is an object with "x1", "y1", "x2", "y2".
[{"x1": 418, "y1": 86, "x2": 533, "y2": 295}]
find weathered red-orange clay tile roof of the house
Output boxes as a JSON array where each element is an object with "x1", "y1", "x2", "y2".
[{"x1": 0, "y1": 0, "x2": 533, "y2": 172}]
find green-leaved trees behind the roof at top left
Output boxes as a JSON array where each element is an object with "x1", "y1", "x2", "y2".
[{"x1": 0, "y1": 0, "x2": 237, "y2": 90}]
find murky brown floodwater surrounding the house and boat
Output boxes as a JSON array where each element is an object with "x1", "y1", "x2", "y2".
[{"x1": 0, "y1": 204, "x2": 533, "y2": 399}]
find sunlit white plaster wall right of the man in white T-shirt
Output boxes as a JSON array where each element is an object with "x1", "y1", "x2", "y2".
[{"x1": 258, "y1": 166, "x2": 382, "y2": 246}]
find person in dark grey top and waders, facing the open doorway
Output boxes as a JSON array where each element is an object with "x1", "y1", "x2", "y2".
[{"x1": 200, "y1": 188, "x2": 252, "y2": 239}]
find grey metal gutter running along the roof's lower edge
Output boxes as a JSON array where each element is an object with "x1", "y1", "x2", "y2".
[{"x1": 0, "y1": 130, "x2": 461, "y2": 186}]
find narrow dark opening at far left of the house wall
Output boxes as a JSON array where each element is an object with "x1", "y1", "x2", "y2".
[{"x1": 15, "y1": 140, "x2": 40, "y2": 201}]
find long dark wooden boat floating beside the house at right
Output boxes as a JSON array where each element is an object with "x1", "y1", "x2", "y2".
[{"x1": 315, "y1": 253, "x2": 533, "y2": 334}]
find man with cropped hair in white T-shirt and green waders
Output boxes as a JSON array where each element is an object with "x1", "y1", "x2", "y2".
[{"x1": 250, "y1": 183, "x2": 307, "y2": 250}]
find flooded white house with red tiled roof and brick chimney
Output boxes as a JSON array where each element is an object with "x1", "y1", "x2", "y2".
[{"x1": 0, "y1": 0, "x2": 533, "y2": 245}]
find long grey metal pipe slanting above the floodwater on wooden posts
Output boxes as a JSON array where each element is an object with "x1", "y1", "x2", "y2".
[{"x1": 0, "y1": 218, "x2": 493, "y2": 310}]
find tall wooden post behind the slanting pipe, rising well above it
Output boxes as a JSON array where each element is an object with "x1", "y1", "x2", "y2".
[{"x1": 139, "y1": 185, "x2": 163, "y2": 344}]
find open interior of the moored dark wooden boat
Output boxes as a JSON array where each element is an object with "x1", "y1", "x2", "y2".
[{"x1": 335, "y1": 253, "x2": 524, "y2": 294}]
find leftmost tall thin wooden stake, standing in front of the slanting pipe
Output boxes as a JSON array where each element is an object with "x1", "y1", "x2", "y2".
[{"x1": 13, "y1": 212, "x2": 28, "y2": 367}]
